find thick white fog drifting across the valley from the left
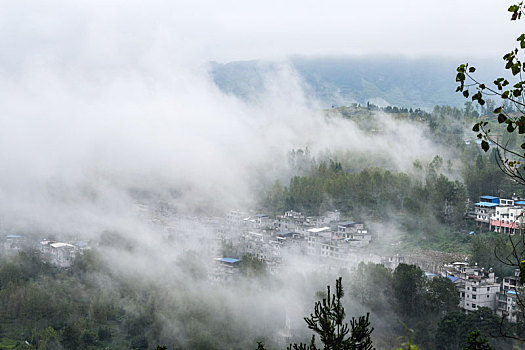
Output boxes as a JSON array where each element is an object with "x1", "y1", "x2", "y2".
[{"x1": 0, "y1": 2, "x2": 476, "y2": 348}]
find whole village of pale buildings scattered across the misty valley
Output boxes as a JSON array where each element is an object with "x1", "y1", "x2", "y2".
[{"x1": 3, "y1": 196, "x2": 525, "y2": 322}]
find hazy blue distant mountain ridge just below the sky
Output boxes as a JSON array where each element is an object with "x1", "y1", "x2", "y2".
[{"x1": 210, "y1": 57, "x2": 503, "y2": 109}]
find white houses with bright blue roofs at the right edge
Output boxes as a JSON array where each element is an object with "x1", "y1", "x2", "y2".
[{"x1": 473, "y1": 196, "x2": 525, "y2": 234}]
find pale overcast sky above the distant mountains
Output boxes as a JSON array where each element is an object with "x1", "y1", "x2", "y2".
[{"x1": 0, "y1": 0, "x2": 523, "y2": 68}]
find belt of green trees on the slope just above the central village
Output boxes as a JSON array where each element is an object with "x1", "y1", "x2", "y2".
[{"x1": 263, "y1": 157, "x2": 466, "y2": 227}]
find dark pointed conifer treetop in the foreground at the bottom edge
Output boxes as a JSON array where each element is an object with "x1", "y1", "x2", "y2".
[{"x1": 288, "y1": 277, "x2": 374, "y2": 350}]
